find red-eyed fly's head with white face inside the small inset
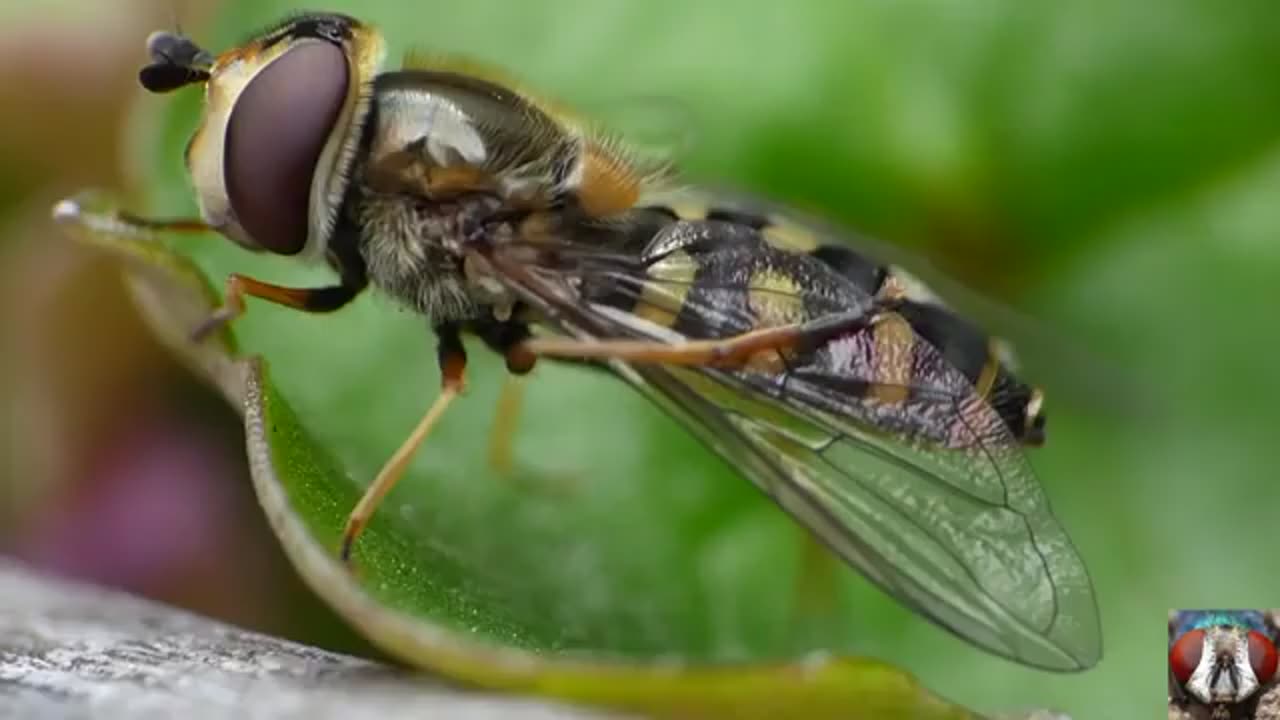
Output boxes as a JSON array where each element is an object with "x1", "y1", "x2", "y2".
[{"x1": 1169, "y1": 611, "x2": 1276, "y2": 705}]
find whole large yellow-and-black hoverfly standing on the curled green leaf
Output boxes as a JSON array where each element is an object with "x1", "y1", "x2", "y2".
[{"x1": 82, "y1": 14, "x2": 1101, "y2": 670}]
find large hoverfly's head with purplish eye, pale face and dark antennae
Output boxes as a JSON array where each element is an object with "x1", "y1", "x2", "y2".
[{"x1": 140, "y1": 14, "x2": 384, "y2": 255}]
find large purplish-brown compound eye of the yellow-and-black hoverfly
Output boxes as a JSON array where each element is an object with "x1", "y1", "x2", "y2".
[{"x1": 223, "y1": 41, "x2": 349, "y2": 255}]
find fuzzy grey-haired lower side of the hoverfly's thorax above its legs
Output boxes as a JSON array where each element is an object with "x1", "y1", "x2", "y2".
[{"x1": 357, "y1": 185, "x2": 509, "y2": 324}]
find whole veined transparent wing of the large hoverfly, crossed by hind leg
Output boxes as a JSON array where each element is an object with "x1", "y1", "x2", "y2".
[{"x1": 481, "y1": 234, "x2": 1101, "y2": 670}]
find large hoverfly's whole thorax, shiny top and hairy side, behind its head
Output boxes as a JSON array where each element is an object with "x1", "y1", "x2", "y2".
[{"x1": 330, "y1": 60, "x2": 655, "y2": 323}]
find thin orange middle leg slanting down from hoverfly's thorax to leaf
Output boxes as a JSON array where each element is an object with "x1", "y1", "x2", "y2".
[{"x1": 340, "y1": 324, "x2": 467, "y2": 562}]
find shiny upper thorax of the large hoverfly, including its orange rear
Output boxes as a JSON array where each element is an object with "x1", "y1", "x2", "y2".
[{"x1": 366, "y1": 64, "x2": 665, "y2": 218}]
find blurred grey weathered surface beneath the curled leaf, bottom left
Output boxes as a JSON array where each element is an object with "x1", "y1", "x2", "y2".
[{"x1": 0, "y1": 559, "x2": 614, "y2": 720}]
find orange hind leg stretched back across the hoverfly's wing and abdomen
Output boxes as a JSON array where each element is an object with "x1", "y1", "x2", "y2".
[{"x1": 508, "y1": 310, "x2": 876, "y2": 369}]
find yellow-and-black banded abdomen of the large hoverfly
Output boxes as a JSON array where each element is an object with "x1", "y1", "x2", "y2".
[{"x1": 616, "y1": 199, "x2": 1044, "y2": 445}]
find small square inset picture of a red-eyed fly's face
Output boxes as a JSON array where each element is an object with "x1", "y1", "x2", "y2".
[{"x1": 1169, "y1": 610, "x2": 1280, "y2": 720}]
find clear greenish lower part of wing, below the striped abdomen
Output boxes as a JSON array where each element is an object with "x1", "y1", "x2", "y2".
[{"x1": 640, "y1": 366, "x2": 1101, "y2": 670}]
